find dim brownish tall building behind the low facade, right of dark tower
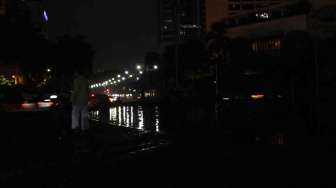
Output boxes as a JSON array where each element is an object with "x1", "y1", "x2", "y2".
[{"x1": 206, "y1": 0, "x2": 295, "y2": 30}]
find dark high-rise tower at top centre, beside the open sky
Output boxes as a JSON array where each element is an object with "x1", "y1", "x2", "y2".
[{"x1": 159, "y1": 0, "x2": 205, "y2": 42}]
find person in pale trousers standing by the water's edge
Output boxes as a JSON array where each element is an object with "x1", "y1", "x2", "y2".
[{"x1": 71, "y1": 71, "x2": 89, "y2": 132}]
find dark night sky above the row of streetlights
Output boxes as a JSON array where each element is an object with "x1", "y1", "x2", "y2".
[{"x1": 47, "y1": 0, "x2": 158, "y2": 71}]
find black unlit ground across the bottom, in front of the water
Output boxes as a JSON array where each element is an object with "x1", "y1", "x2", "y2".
[{"x1": 0, "y1": 111, "x2": 336, "y2": 187}]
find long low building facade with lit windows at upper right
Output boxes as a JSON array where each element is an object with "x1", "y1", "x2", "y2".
[{"x1": 219, "y1": 1, "x2": 336, "y2": 51}]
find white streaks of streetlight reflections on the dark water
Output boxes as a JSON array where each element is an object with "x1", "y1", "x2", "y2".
[{"x1": 90, "y1": 106, "x2": 160, "y2": 132}]
